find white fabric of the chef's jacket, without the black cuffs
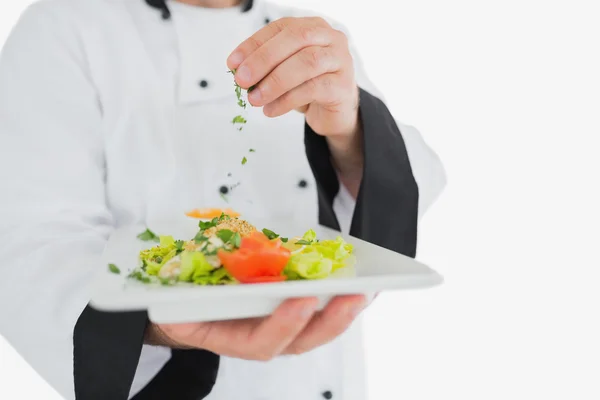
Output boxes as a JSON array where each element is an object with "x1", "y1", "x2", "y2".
[{"x1": 0, "y1": 0, "x2": 445, "y2": 400}]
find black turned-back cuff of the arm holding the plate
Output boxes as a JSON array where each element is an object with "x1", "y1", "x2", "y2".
[{"x1": 73, "y1": 306, "x2": 219, "y2": 400}]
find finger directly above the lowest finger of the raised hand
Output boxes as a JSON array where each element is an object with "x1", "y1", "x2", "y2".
[{"x1": 248, "y1": 46, "x2": 345, "y2": 107}]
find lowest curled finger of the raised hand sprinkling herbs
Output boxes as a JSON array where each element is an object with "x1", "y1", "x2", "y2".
[{"x1": 263, "y1": 73, "x2": 353, "y2": 118}]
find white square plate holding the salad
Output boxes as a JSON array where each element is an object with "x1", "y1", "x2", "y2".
[{"x1": 91, "y1": 219, "x2": 443, "y2": 323}]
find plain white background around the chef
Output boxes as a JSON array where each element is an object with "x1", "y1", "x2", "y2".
[{"x1": 0, "y1": 0, "x2": 600, "y2": 400}]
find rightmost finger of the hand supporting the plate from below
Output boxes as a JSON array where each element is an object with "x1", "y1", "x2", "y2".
[{"x1": 284, "y1": 295, "x2": 366, "y2": 354}]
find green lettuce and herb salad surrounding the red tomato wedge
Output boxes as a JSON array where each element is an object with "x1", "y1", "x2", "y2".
[{"x1": 129, "y1": 214, "x2": 355, "y2": 285}]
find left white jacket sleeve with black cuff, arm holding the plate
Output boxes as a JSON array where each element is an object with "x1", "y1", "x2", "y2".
[{"x1": 0, "y1": 2, "x2": 218, "y2": 400}]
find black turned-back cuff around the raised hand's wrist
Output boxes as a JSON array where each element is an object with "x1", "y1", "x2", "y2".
[{"x1": 304, "y1": 89, "x2": 419, "y2": 257}]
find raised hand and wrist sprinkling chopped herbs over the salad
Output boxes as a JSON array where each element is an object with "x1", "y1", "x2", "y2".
[{"x1": 227, "y1": 17, "x2": 363, "y2": 195}]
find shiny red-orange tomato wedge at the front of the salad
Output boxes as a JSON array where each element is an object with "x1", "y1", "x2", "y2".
[{"x1": 218, "y1": 232, "x2": 291, "y2": 283}]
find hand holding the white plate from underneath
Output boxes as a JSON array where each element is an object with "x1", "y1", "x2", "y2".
[{"x1": 146, "y1": 295, "x2": 366, "y2": 361}]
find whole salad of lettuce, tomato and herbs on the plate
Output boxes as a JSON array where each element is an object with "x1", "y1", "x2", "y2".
[{"x1": 109, "y1": 210, "x2": 355, "y2": 285}]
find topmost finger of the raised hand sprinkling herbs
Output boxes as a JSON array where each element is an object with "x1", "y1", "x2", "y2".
[{"x1": 227, "y1": 17, "x2": 328, "y2": 69}]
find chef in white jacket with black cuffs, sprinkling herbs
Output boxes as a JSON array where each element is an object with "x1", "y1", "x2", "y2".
[{"x1": 0, "y1": 0, "x2": 445, "y2": 400}]
